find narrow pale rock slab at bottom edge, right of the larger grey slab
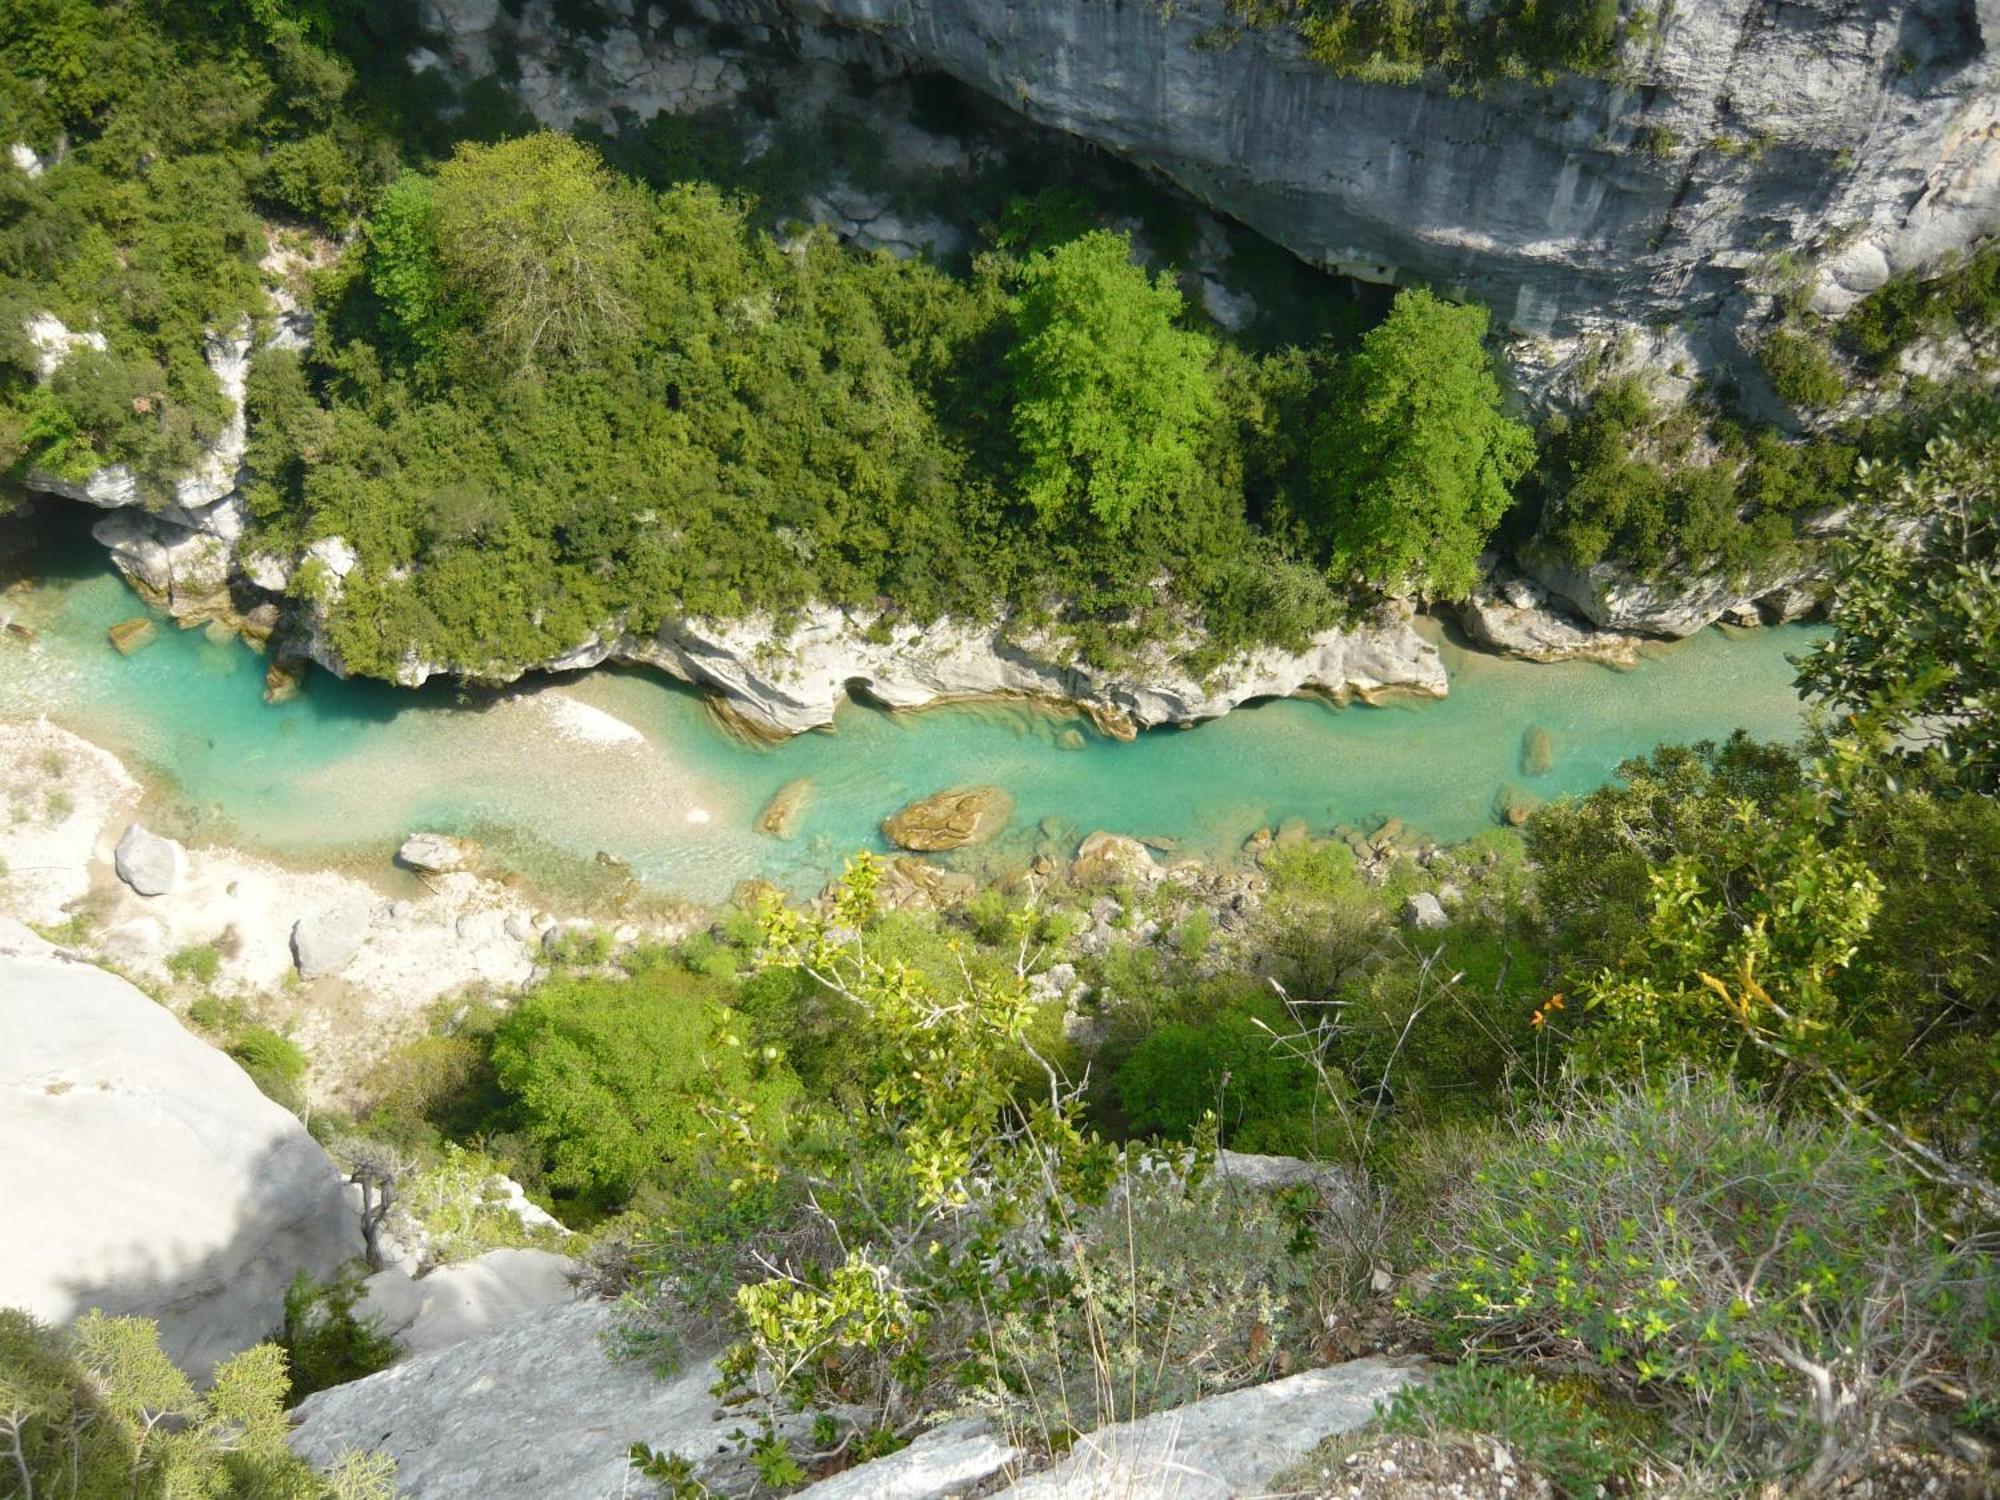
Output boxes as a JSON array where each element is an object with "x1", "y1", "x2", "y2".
[{"x1": 998, "y1": 1360, "x2": 1418, "y2": 1500}]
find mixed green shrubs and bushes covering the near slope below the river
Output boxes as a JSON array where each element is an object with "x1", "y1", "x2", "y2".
[{"x1": 230, "y1": 430, "x2": 2000, "y2": 1496}]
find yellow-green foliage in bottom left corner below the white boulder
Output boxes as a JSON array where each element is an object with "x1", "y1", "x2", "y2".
[{"x1": 0, "y1": 1308, "x2": 394, "y2": 1500}]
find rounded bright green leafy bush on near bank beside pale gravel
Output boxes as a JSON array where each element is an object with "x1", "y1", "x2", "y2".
[{"x1": 494, "y1": 966, "x2": 794, "y2": 1210}]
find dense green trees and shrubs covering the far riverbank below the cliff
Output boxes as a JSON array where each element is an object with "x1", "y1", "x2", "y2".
[{"x1": 0, "y1": 0, "x2": 1944, "y2": 676}]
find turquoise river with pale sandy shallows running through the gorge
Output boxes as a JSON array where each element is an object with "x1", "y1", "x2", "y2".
[{"x1": 0, "y1": 548, "x2": 1814, "y2": 900}]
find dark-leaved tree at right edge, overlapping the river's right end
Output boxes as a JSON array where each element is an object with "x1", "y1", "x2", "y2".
[{"x1": 1800, "y1": 406, "x2": 2000, "y2": 792}]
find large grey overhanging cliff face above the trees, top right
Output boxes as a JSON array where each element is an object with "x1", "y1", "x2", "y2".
[{"x1": 736, "y1": 0, "x2": 2000, "y2": 364}]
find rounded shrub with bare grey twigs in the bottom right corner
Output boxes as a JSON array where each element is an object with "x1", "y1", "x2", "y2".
[{"x1": 1418, "y1": 1082, "x2": 2000, "y2": 1492}]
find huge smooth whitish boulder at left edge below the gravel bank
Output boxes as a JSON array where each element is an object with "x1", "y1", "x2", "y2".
[{"x1": 0, "y1": 918, "x2": 362, "y2": 1374}]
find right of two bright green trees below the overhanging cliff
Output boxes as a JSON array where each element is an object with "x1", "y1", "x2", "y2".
[{"x1": 1314, "y1": 288, "x2": 1534, "y2": 598}]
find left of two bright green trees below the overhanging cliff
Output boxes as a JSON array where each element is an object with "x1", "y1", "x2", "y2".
[{"x1": 1008, "y1": 230, "x2": 1218, "y2": 532}]
